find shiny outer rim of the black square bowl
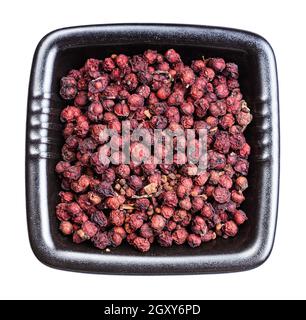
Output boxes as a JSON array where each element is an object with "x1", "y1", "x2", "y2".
[{"x1": 26, "y1": 23, "x2": 280, "y2": 275}]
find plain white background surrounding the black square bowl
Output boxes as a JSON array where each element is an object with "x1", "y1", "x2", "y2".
[{"x1": 0, "y1": 0, "x2": 306, "y2": 299}]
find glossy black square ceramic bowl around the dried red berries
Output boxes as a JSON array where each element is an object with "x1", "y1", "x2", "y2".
[{"x1": 26, "y1": 24, "x2": 279, "y2": 274}]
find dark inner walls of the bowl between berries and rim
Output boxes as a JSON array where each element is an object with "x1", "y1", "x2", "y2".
[{"x1": 42, "y1": 39, "x2": 270, "y2": 257}]
